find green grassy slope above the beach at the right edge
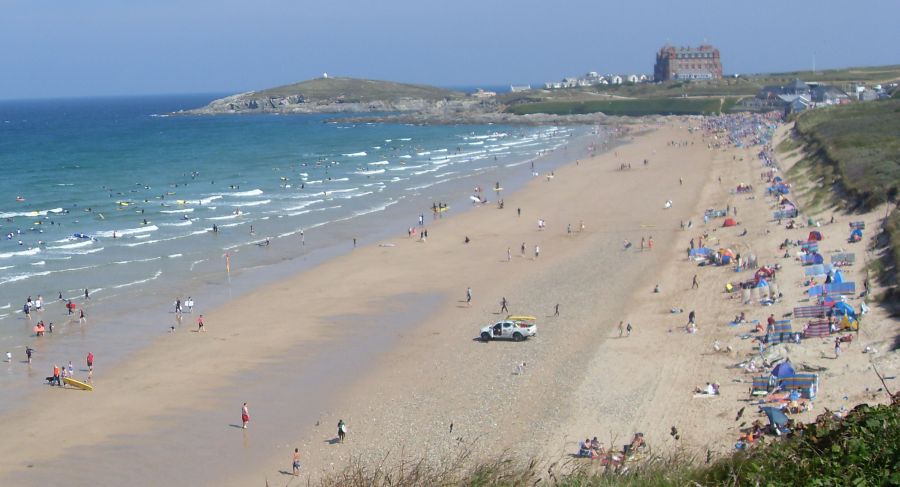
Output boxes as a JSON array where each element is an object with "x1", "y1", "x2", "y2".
[{"x1": 795, "y1": 100, "x2": 900, "y2": 209}]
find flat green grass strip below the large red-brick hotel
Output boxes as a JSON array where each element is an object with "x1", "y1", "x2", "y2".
[{"x1": 508, "y1": 98, "x2": 734, "y2": 116}]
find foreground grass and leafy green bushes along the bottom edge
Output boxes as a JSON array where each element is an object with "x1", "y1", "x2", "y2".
[{"x1": 321, "y1": 398, "x2": 900, "y2": 487}]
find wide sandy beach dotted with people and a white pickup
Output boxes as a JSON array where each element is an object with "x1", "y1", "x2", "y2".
[{"x1": 0, "y1": 118, "x2": 898, "y2": 485}]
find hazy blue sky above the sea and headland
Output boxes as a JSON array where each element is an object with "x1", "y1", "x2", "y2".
[{"x1": 0, "y1": 0, "x2": 900, "y2": 99}]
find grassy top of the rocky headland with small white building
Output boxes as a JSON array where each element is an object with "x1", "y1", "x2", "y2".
[{"x1": 253, "y1": 78, "x2": 464, "y2": 103}]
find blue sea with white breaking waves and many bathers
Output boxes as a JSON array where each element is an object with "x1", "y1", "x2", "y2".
[{"x1": 0, "y1": 95, "x2": 599, "y2": 408}]
